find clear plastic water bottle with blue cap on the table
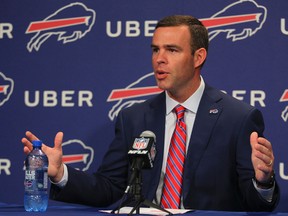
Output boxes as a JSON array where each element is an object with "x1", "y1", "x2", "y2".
[{"x1": 24, "y1": 140, "x2": 48, "y2": 212}]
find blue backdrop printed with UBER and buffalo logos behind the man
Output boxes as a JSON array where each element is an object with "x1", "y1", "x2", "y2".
[{"x1": 0, "y1": 0, "x2": 288, "y2": 212}]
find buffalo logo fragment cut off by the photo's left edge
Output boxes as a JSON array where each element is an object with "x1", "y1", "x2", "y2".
[{"x1": 0, "y1": 72, "x2": 14, "y2": 106}]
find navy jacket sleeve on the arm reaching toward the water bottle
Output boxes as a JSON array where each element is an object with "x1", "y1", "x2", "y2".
[{"x1": 50, "y1": 110, "x2": 128, "y2": 207}]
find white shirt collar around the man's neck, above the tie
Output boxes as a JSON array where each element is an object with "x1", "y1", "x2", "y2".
[{"x1": 165, "y1": 76, "x2": 205, "y2": 115}]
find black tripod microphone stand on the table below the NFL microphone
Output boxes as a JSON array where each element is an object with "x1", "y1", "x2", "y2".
[{"x1": 111, "y1": 168, "x2": 172, "y2": 215}]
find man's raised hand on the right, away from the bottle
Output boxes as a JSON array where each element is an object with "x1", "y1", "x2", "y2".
[{"x1": 250, "y1": 132, "x2": 274, "y2": 183}]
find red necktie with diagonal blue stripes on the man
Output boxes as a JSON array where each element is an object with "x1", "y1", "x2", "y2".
[{"x1": 161, "y1": 105, "x2": 186, "y2": 209}]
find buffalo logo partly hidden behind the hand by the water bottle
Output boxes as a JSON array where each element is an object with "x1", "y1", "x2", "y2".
[{"x1": 62, "y1": 139, "x2": 94, "y2": 171}]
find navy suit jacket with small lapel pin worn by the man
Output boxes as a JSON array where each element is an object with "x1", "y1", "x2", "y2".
[{"x1": 50, "y1": 85, "x2": 279, "y2": 211}]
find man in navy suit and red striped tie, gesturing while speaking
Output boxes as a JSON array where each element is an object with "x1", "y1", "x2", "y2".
[{"x1": 22, "y1": 15, "x2": 279, "y2": 211}]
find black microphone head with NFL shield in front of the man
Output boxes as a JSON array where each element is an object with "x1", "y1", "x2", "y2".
[{"x1": 128, "y1": 131, "x2": 156, "y2": 170}]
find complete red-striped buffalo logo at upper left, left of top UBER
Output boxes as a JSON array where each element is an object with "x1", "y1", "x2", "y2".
[{"x1": 26, "y1": 2, "x2": 96, "y2": 52}]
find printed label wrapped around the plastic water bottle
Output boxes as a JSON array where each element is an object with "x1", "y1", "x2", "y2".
[{"x1": 24, "y1": 170, "x2": 48, "y2": 192}]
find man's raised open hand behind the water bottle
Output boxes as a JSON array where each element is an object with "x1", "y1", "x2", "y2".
[{"x1": 21, "y1": 131, "x2": 64, "y2": 183}]
